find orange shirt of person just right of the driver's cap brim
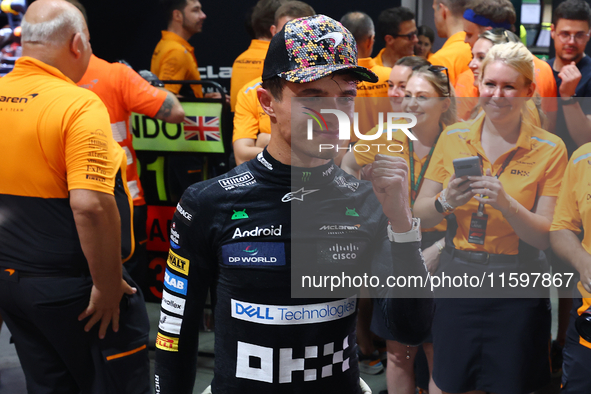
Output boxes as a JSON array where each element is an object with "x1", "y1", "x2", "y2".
[{"x1": 351, "y1": 57, "x2": 392, "y2": 141}]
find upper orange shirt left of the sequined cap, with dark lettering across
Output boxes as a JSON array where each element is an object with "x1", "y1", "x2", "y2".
[{"x1": 230, "y1": 40, "x2": 271, "y2": 112}]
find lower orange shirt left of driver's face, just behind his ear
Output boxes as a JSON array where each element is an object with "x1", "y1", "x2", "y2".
[{"x1": 232, "y1": 77, "x2": 271, "y2": 142}]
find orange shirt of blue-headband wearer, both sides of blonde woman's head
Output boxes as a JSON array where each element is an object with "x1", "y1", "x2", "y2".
[{"x1": 455, "y1": 56, "x2": 558, "y2": 119}]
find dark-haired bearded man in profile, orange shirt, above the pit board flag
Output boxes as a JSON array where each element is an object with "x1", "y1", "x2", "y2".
[{"x1": 150, "y1": 0, "x2": 224, "y2": 100}]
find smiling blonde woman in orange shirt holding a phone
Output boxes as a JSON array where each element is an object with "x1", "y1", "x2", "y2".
[{"x1": 414, "y1": 43, "x2": 566, "y2": 394}]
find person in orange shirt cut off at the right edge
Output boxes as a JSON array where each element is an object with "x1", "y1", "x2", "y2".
[{"x1": 550, "y1": 144, "x2": 591, "y2": 394}]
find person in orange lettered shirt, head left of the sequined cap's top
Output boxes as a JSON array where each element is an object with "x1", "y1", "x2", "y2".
[{"x1": 230, "y1": 0, "x2": 287, "y2": 112}]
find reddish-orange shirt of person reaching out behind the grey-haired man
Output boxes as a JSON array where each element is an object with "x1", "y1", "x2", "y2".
[{"x1": 78, "y1": 55, "x2": 167, "y2": 209}]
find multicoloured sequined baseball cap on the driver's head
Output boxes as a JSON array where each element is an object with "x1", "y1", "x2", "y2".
[{"x1": 263, "y1": 15, "x2": 378, "y2": 83}]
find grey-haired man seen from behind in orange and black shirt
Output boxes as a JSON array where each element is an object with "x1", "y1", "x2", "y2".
[{"x1": 0, "y1": 0, "x2": 151, "y2": 394}]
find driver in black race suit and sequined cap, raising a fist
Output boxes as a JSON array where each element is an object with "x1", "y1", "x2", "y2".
[{"x1": 155, "y1": 15, "x2": 433, "y2": 394}]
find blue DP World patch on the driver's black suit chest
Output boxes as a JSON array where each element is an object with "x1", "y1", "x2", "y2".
[{"x1": 222, "y1": 242, "x2": 285, "y2": 267}]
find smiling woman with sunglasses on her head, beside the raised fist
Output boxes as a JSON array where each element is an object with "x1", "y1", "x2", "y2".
[{"x1": 343, "y1": 57, "x2": 456, "y2": 394}]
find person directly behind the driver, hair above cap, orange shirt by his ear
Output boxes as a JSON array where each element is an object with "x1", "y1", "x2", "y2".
[{"x1": 232, "y1": 1, "x2": 316, "y2": 165}]
